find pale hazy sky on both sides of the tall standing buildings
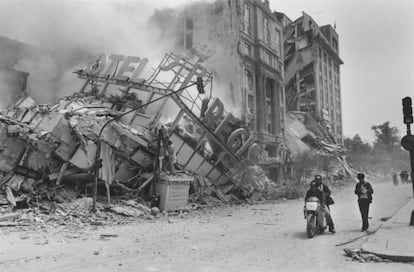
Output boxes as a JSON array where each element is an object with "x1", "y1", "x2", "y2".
[{"x1": 0, "y1": 0, "x2": 414, "y2": 142}]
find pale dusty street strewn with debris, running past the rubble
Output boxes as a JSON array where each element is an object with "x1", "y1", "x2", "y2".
[{"x1": 0, "y1": 178, "x2": 414, "y2": 272}]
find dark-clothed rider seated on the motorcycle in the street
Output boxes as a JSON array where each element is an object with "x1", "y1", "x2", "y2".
[{"x1": 305, "y1": 175, "x2": 336, "y2": 233}]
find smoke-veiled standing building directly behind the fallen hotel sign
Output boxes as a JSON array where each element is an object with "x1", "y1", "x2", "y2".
[{"x1": 150, "y1": 0, "x2": 286, "y2": 180}]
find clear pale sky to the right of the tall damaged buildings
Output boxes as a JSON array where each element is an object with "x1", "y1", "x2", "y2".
[{"x1": 154, "y1": 0, "x2": 414, "y2": 142}]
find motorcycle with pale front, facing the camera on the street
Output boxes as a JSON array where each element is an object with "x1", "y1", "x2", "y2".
[{"x1": 303, "y1": 196, "x2": 326, "y2": 238}]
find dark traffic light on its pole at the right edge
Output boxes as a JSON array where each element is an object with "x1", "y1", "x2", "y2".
[{"x1": 401, "y1": 96, "x2": 414, "y2": 226}]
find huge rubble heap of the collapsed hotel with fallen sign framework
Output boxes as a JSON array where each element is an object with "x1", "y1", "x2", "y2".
[{"x1": 0, "y1": 53, "x2": 281, "y2": 211}]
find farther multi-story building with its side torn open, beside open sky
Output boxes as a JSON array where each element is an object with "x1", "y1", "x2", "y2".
[{"x1": 276, "y1": 12, "x2": 343, "y2": 145}]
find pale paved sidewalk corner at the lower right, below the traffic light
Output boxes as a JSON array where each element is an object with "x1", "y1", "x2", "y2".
[{"x1": 362, "y1": 200, "x2": 414, "y2": 262}]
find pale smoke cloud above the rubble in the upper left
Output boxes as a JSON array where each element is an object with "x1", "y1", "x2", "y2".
[{"x1": 0, "y1": 0, "x2": 192, "y2": 103}]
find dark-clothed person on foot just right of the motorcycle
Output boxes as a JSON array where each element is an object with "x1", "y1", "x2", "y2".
[{"x1": 355, "y1": 173, "x2": 374, "y2": 231}]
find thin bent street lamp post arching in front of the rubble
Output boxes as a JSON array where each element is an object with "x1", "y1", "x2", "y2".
[{"x1": 92, "y1": 81, "x2": 204, "y2": 212}]
